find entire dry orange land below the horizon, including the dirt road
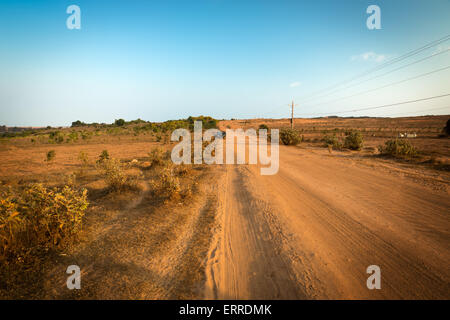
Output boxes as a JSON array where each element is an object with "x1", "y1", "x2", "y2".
[{"x1": 0, "y1": 116, "x2": 450, "y2": 299}]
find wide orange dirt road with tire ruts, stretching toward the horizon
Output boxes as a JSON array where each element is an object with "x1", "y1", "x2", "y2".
[{"x1": 205, "y1": 147, "x2": 450, "y2": 299}]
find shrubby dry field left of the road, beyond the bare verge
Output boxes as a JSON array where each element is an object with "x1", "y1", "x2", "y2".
[{"x1": 0, "y1": 116, "x2": 217, "y2": 298}]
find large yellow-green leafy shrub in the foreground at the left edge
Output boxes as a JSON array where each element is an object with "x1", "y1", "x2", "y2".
[{"x1": 0, "y1": 184, "x2": 89, "y2": 258}]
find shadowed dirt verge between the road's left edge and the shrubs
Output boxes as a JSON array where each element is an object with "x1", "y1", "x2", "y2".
[{"x1": 38, "y1": 168, "x2": 217, "y2": 299}]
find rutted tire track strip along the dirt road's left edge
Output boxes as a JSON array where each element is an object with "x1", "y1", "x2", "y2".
[{"x1": 205, "y1": 166, "x2": 306, "y2": 299}]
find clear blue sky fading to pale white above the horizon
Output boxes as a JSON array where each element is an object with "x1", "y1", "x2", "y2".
[{"x1": 0, "y1": 0, "x2": 450, "y2": 126}]
